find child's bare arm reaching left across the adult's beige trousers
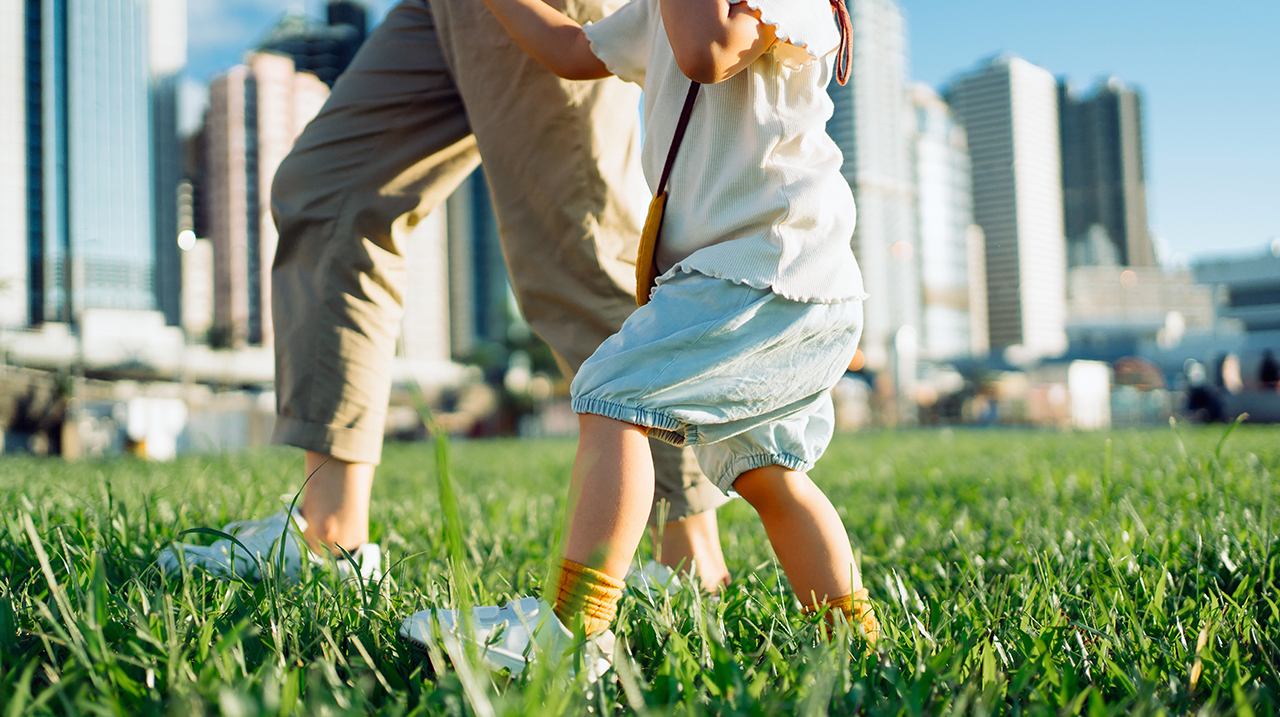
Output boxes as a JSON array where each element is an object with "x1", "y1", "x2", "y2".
[{"x1": 484, "y1": 0, "x2": 613, "y2": 79}]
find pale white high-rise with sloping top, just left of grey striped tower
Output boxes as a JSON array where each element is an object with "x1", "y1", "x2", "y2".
[{"x1": 911, "y1": 85, "x2": 987, "y2": 360}]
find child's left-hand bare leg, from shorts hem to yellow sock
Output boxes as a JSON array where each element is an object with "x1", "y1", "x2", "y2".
[{"x1": 564, "y1": 414, "x2": 653, "y2": 580}]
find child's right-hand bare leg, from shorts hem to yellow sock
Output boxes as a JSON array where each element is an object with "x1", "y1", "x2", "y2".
[{"x1": 733, "y1": 466, "x2": 863, "y2": 606}]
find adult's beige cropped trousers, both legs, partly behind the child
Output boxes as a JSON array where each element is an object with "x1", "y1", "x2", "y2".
[{"x1": 271, "y1": 0, "x2": 724, "y2": 520}]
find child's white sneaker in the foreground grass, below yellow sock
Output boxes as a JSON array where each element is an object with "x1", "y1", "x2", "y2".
[{"x1": 399, "y1": 598, "x2": 614, "y2": 682}]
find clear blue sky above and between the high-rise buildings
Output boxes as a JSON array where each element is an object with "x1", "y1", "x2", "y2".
[{"x1": 188, "y1": 0, "x2": 1280, "y2": 260}]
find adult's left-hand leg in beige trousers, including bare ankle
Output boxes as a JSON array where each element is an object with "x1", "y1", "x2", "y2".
[{"x1": 271, "y1": 0, "x2": 479, "y2": 549}]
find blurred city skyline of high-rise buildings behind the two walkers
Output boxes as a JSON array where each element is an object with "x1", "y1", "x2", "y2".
[{"x1": 0, "y1": 0, "x2": 1280, "y2": 414}]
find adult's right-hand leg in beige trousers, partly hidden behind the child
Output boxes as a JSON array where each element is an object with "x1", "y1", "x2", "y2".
[{"x1": 431, "y1": 0, "x2": 728, "y2": 589}]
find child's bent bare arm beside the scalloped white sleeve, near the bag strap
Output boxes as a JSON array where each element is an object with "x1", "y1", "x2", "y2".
[{"x1": 662, "y1": 0, "x2": 778, "y2": 85}]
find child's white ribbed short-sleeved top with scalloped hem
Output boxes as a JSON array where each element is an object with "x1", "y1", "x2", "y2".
[{"x1": 585, "y1": 0, "x2": 867, "y2": 303}]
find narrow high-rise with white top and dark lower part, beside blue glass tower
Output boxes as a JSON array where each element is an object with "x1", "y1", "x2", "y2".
[{"x1": 148, "y1": 0, "x2": 187, "y2": 326}]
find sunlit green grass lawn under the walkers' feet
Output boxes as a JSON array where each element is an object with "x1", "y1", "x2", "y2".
[{"x1": 0, "y1": 426, "x2": 1280, "y2": 717}]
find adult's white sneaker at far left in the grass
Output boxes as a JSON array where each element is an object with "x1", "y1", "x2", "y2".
[{"x1": 156, "y1": 510, "x2": 383, "y2": 581}]
